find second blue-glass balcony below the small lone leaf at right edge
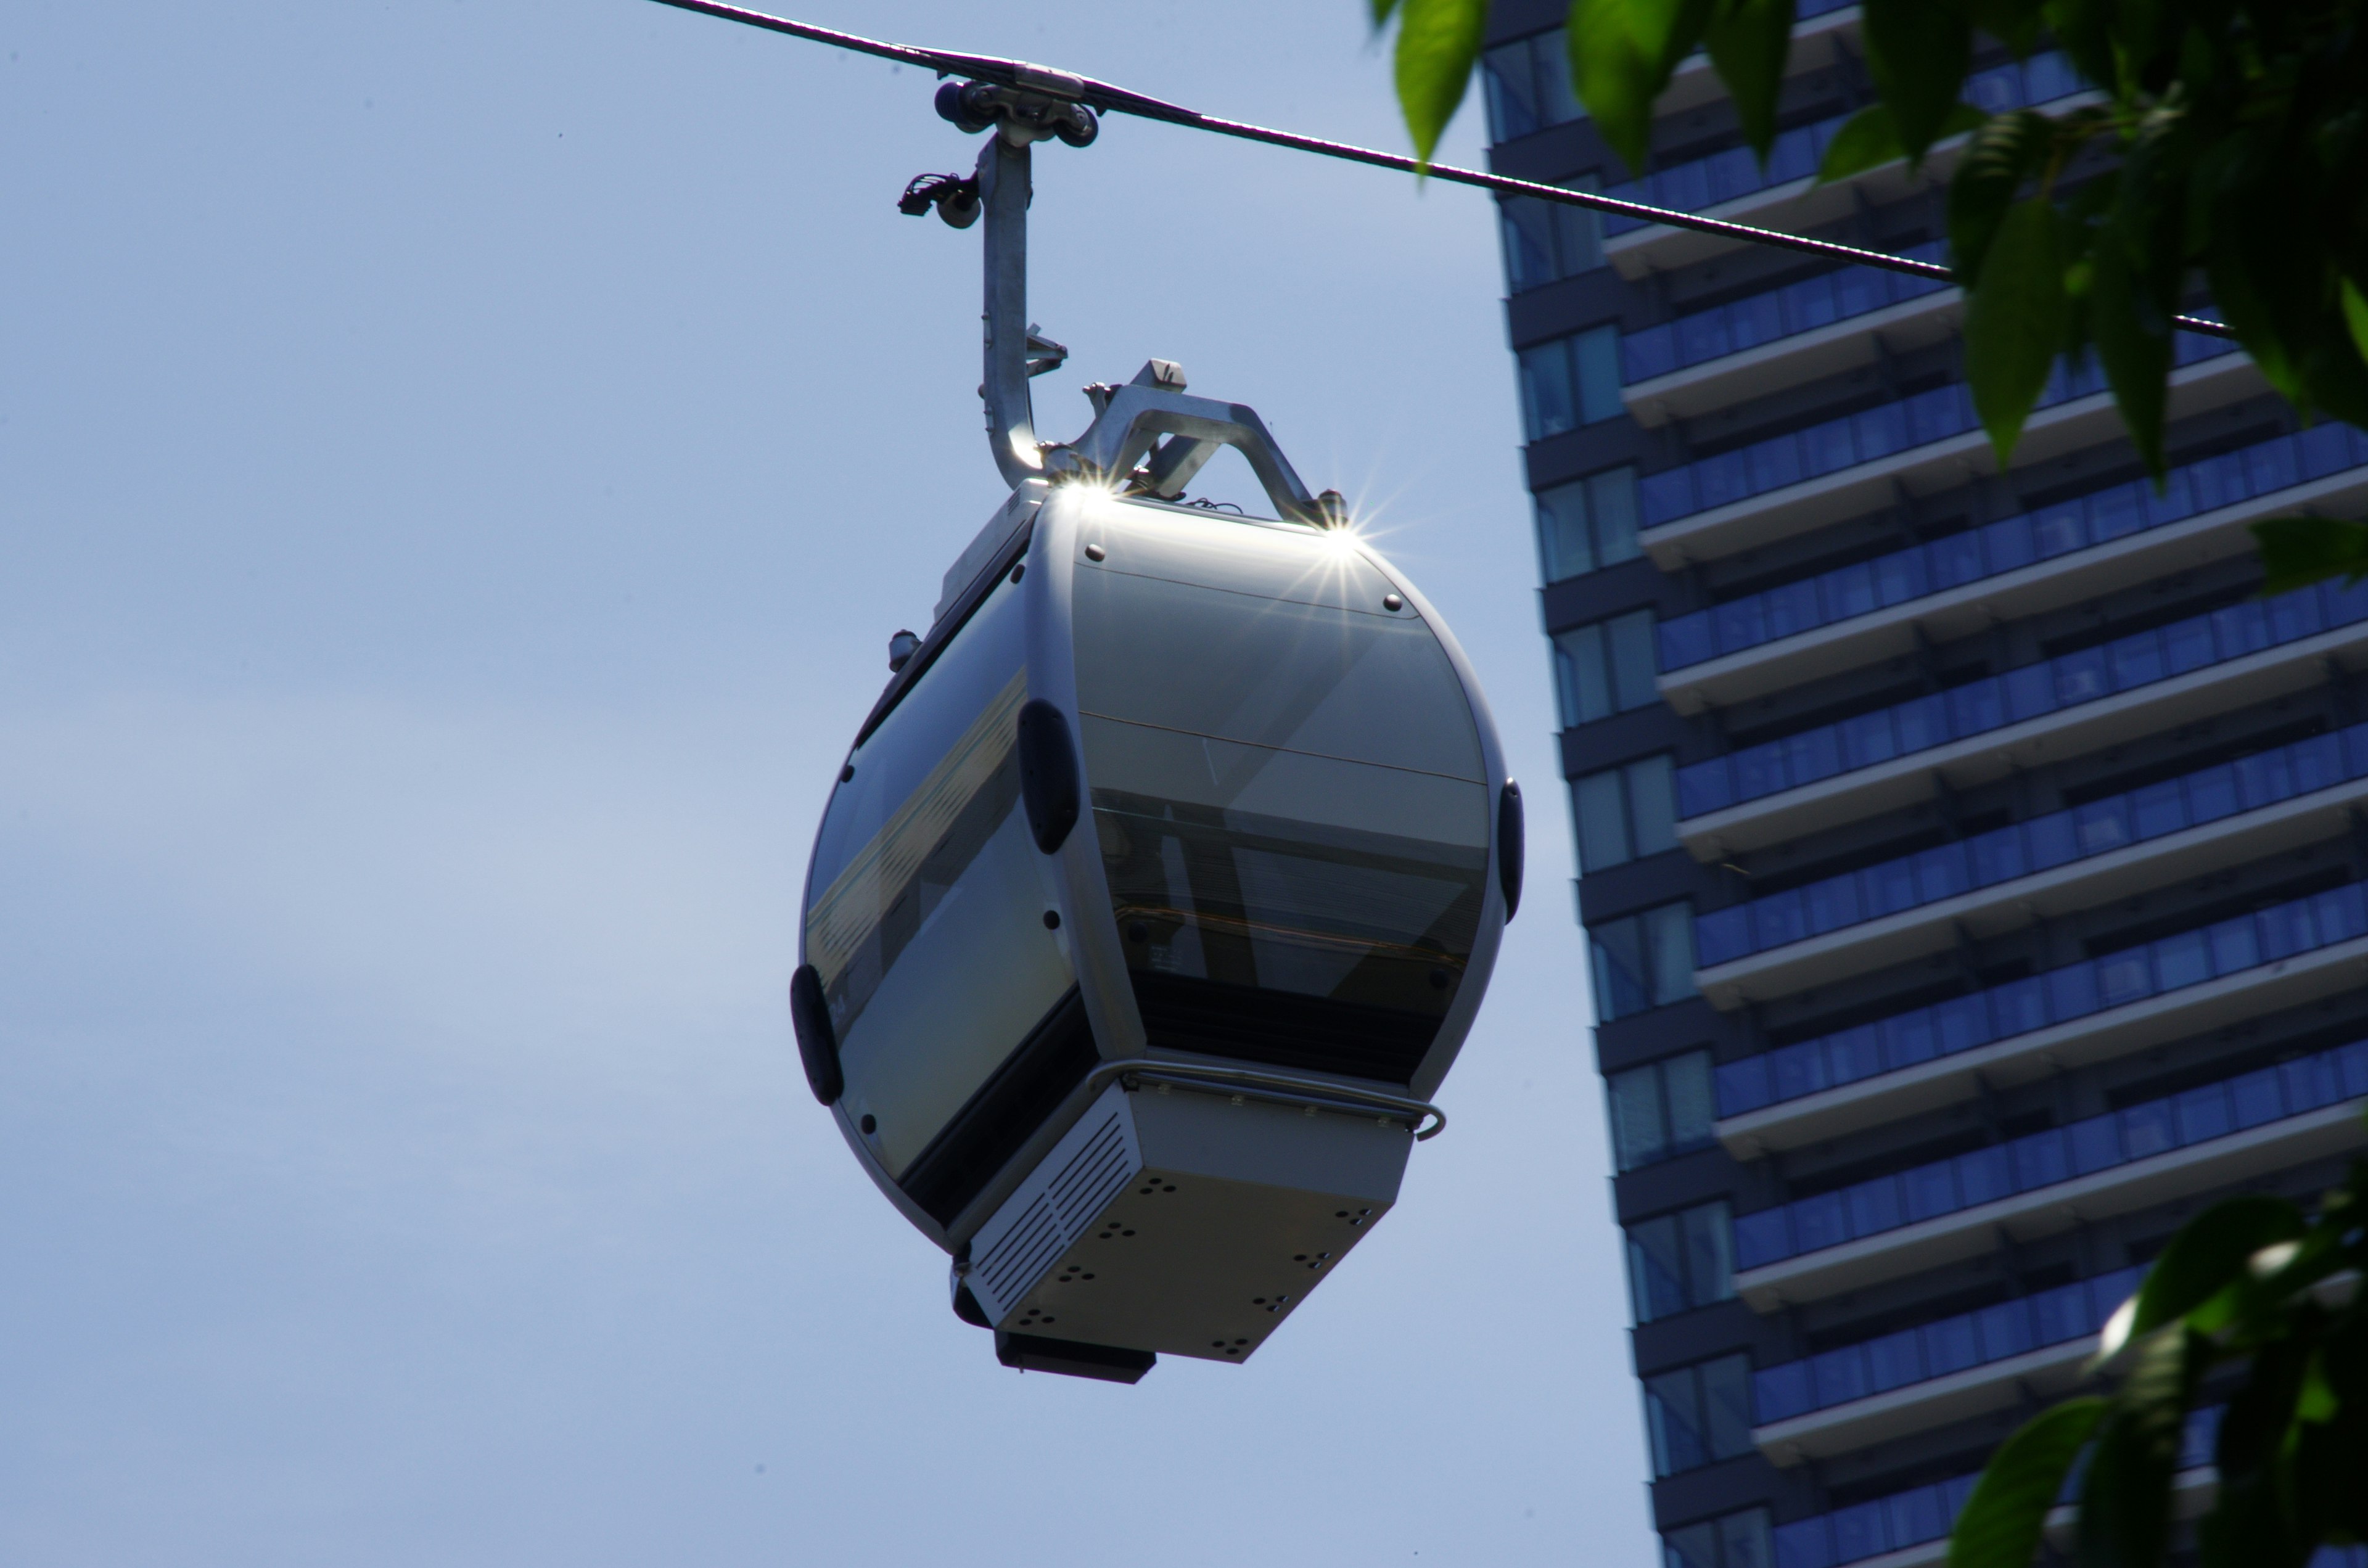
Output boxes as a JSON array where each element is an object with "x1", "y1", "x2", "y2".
[{"x1": 1693, "y1": 724, "x2": 2368, "y2": 1009}]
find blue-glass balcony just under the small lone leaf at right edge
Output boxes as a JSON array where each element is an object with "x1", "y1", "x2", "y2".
[{"x1": 1677, "y1": 583, "x2": 2368, "y2": 862}]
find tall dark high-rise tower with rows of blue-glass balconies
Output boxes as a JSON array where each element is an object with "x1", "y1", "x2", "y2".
[{"x1": 1482, "y1": 0, "x2": 2368, "y2": 1568}]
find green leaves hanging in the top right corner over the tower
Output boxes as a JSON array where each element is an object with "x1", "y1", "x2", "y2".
[{"x1": 1369, "y1": 0, "x2": 2368, "y2": 592}]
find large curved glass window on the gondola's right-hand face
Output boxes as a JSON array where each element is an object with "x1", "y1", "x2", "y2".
[{"x1": 1075, "y1": 523, "x2": 1489, "y2": 1083}]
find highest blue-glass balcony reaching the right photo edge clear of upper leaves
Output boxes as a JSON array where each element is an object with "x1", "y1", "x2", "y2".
[{"x1": 1658, "y1": 424, "x2": 2368, "y2": 713}]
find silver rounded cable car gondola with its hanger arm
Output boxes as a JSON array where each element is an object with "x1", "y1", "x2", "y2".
[{"x1": 791, "y1": 73, "x2": 1523, "y2": 1383}]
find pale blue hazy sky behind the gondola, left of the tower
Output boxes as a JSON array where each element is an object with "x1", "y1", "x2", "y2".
[{"x1": 0, "y1": 0, "x2": 1650, "y2": 1568}]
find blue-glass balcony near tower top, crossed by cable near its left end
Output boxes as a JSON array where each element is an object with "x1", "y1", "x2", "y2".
[{"x1": 1603, "y1": 50, "x2": 2098, "y2": 282}]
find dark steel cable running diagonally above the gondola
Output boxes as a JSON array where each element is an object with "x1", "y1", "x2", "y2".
[{"x1": 656, "y1": 0, "x2": 2235, "y2": 339}]
